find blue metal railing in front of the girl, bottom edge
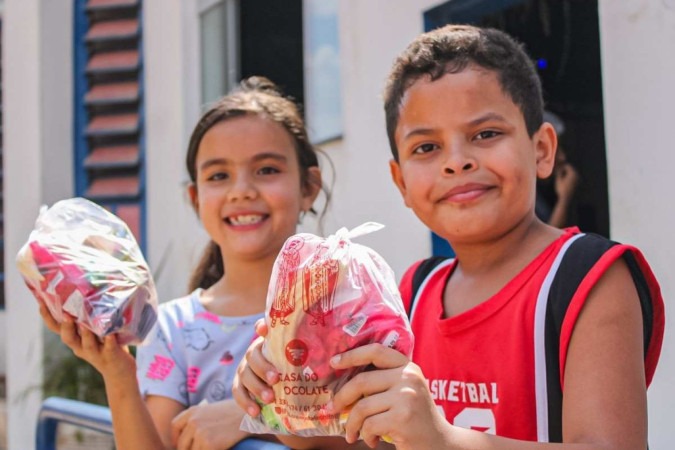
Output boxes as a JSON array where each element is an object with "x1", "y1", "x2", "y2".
[{"x1": 35, "y1": 397, "x2": 289, "y2": 450}]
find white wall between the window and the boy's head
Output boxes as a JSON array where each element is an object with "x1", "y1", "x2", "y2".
[{"x1": 327, "y1": 0, "x2": 439, "y2": 277}]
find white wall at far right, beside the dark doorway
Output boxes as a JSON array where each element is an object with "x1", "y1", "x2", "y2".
[{"x1": 600, "y1": 0, "x2": 675, "y2": 450}]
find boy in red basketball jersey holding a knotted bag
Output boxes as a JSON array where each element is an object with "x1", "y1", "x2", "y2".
[{"x1": 235, "y1": 26, "x2": 664, "y2": 450}]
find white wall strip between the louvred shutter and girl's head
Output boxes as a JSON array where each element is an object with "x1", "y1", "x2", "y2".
[{"x1": 143, "y1": 0, "x2": 205, "y2": 301}]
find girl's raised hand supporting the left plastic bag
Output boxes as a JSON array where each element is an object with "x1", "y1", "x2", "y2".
[{"x1": 38, "y1": 300, "x2": 136, "y2": 382}]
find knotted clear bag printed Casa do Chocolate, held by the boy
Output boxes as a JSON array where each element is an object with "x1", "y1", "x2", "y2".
[{"x1": 241, "y1": 223, "x2": 413, "y2": 436}]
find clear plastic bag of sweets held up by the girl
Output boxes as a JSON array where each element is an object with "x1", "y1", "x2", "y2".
[{"x1": 16, "y1": 198, "x2": 157, "y2": 345}]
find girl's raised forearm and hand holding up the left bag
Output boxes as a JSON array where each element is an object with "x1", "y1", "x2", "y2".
[{"x1": 40, "y1": 303, "x2": 184, "y2": 450}]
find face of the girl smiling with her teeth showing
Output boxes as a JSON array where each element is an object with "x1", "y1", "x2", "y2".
[{"x1": 190, "y1": 115, "x2": 321, "y2": 266}]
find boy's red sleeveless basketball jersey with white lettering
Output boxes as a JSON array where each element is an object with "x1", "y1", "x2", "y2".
[{"x1": 401, "y1": 229, "x2": 664, "y2": 442}]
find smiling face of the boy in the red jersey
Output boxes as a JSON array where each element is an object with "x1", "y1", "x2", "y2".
[{"x1": 391, "y1": 66, "x2": 556, "y2": 244}]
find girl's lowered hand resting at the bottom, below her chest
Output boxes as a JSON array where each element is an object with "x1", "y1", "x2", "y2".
[{"x1": 171, "y1": 399, "x2": 248, "y2": 450}]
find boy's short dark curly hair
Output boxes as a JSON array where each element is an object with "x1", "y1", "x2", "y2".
[{"x1": 384, "y1": 25, "x2": 544, "y2": 161}]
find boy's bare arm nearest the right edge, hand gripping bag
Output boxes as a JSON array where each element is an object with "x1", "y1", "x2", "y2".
[{"x1": 333, "y1": 260, "x2": 647, "y2": 450}]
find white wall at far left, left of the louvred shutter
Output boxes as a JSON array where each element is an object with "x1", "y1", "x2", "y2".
[{"x1": 2, "y1": 0, "x2": 72, "y2": 442}]
